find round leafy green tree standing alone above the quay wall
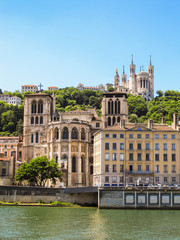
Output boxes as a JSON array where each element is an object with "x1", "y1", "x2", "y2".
[{"x1": 15, "y1": 156, "x2": 62, "y2": 187}]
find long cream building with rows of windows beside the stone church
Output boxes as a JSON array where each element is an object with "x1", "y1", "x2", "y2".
[{"x1": 93, "y1": 114, "x2": 180, "y2": 186}]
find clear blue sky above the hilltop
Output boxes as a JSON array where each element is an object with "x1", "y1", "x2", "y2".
[{"x1": 0, "y1": 0, "x2": 180, "y2": 92}]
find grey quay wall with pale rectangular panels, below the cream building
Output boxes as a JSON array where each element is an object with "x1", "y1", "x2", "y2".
[{"x1": 98, "y1": 188, "x2": 180, "y2": 209}]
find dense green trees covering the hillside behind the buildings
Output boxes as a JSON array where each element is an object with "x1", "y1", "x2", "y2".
[{"x1": 0, "y1": 87, "x2": 180, "y2": 136}]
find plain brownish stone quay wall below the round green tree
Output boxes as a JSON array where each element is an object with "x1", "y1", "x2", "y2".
[{"x1": 0, "y1": 186, "x2": 98, "y2": 206}]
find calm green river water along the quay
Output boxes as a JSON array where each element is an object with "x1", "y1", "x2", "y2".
[{"x1": 0, "y1": 206, "x2": 180, "y2": 240}]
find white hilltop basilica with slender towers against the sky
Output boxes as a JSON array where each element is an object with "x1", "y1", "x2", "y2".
[{"x1": 114, "y1": 56, "x2": 154, "y2": 100}]
